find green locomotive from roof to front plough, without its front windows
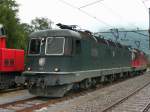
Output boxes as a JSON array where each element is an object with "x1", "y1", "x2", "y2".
[{"x1": 23, "y1": 29, "x2": 135, "y2": 97}]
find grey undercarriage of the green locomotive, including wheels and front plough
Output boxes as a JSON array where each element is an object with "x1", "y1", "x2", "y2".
[{"x1": 24, "y1": 68, "x2": 144, "y2": 97}]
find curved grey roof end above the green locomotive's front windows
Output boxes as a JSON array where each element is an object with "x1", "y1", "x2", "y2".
[{"x1": 30, "y1": 29, "x2": 82, "y2": 39}]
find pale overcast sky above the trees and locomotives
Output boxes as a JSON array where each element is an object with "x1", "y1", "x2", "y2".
[{"x1": 16, "y1": 0, "x2": 150, "y2": 31}]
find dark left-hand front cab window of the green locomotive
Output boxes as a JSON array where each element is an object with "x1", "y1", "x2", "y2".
[{"x1": 29, "y1": 39, "x2": 41, "y2": 54}]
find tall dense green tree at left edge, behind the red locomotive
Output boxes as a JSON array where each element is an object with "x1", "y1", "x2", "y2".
[{"x1": 0, "y1": 0, "x2": 27, "y2": 49}]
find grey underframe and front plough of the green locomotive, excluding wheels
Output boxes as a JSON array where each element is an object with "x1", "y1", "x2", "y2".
[{"x1": 23, "y1": 67, "x2": 146, "y2": 97}]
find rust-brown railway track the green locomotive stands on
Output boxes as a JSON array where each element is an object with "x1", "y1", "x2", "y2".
[{"x1": 0, "y1": 74, "x2": 150, "y2": 112}]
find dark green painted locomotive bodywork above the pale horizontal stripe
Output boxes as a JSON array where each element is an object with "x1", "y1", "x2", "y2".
[{"x1": 26, "y1": 30, "x2": 131, "y2": 72}]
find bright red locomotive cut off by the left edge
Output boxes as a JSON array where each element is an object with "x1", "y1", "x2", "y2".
[{"x1": 0, "y1": 25, "x2": 24, "y2": 89}]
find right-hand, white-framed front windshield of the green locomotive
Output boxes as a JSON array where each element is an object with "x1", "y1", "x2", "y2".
[{"x1": 46, "y1": 37, "x2": 65, "y2": 55}]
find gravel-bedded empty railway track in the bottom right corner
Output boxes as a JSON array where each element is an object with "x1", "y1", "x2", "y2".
[{"x1": 102, "y1": 82, "x2": 150, "y2": 112}]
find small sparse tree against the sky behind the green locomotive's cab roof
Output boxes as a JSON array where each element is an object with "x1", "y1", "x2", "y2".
[{"x1": 31, "y1": 17, "x2": 53, "y2": 31}]
